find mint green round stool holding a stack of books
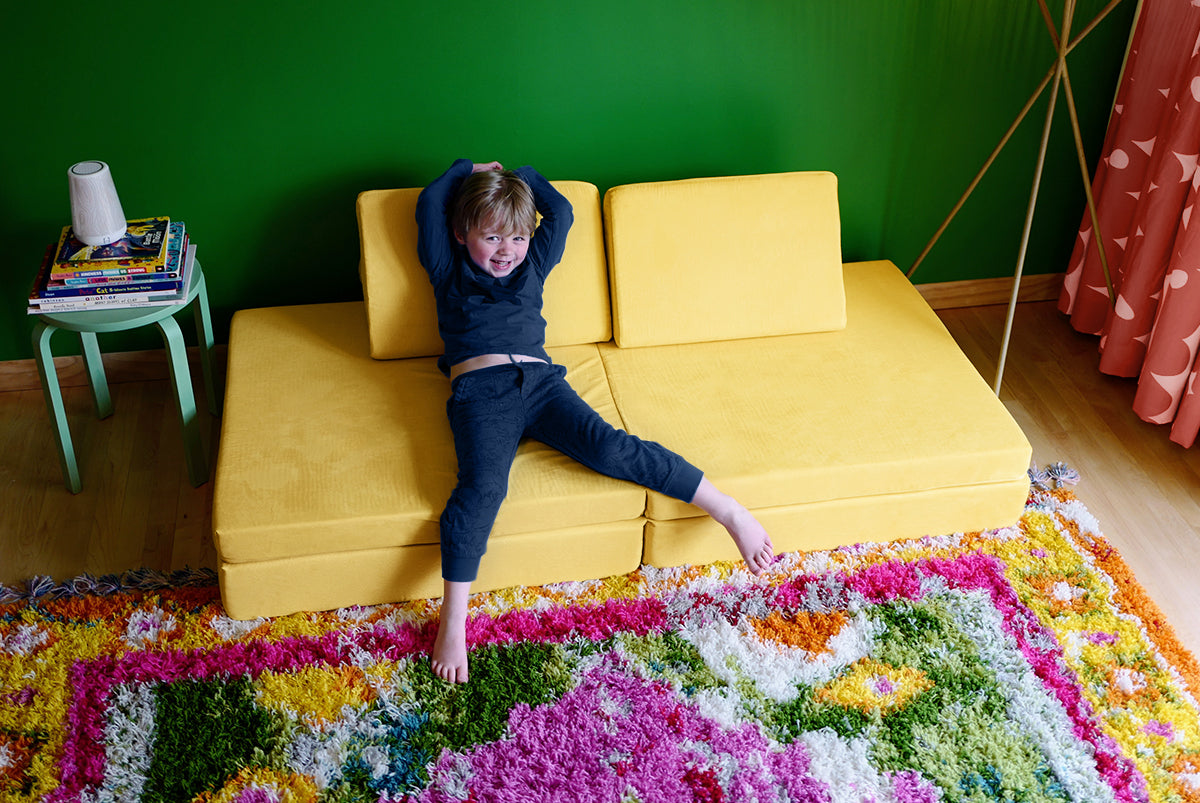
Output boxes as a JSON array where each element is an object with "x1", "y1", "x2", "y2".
[{"x1": 34, "y1": 262, "x2": 221, "y2": 493}]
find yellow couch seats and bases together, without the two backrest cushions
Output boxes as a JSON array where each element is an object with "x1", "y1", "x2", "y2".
[{"x1": 214, "y1": 263, "x2": 1030, "y2": 618}]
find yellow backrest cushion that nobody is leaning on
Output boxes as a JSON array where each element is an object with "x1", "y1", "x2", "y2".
[{"x1": 605, "y1": 173, "x2": 846, "y2": 348}]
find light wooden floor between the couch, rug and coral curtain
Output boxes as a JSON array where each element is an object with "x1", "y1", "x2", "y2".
[{"x1": 938, "y1": 301, "x2": 1200, "y2": 657}]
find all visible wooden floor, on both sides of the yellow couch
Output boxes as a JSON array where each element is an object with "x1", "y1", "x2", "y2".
[{"x1": 0, "y1": 302, "x2": 1200, "y2": 655}]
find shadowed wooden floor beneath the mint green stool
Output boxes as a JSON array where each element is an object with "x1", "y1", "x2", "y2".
[{"x1": 0, "y1": 355, "x2": 220, "y2": 583}]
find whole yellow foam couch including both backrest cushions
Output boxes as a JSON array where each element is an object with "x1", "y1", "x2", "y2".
[{"x1": 212, "y1": 173, "x2": 1031, "y2": 618}]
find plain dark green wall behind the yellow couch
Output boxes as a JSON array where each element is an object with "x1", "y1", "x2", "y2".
[{"x1": 0, "y1": 0, "x2": 1133, "y2": 360}]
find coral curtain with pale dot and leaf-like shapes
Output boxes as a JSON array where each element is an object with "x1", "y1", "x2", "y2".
[{"x1": 1058, "y1": 0, "x2": 1200, "y2": 447}]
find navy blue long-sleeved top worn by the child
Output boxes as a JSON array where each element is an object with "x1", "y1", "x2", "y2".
[{"x1": 416, "y1": 158, "x2": 574, "y2": 376}]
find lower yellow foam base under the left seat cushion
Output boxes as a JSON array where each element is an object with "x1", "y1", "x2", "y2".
[{"x1": 220, "y1": 519, "x2": 644, "y2": 619}]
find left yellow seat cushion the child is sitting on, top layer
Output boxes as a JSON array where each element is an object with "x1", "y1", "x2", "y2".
[{"x1": 212, "y1": 302, "x2": 646, "y2": 564}]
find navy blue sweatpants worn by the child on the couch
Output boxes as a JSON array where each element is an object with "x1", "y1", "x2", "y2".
[{"x1": 440, "y1": 362, "x2": 703, "y2": 582}]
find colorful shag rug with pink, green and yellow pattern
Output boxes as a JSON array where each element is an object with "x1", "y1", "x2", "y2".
[{"x1": 0, "y1": 478, "x2": 1200, "y2": 803}]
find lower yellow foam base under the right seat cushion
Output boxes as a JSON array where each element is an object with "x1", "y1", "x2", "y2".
[{"x1": 642, "y1": 480, "x2": 1030, "y2": 568}]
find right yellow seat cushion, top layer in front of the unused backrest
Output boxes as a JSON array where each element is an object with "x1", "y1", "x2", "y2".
[{"x1": 601, "y1": 262, "x2": 1031, "y2": 549}]
